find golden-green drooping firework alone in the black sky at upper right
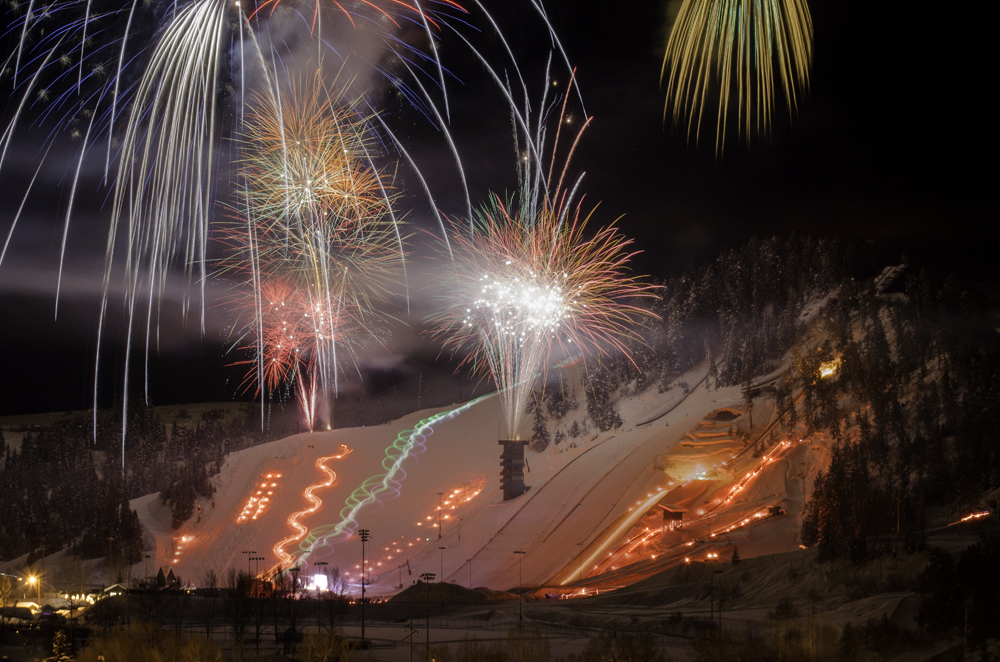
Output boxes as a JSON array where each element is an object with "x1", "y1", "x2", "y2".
[{"x1": 660, "y1": 0, "x2": 812, "y2": 153}]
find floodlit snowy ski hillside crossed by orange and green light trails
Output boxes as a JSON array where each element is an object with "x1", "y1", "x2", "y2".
[{"x1": 132, "y1": 340, "x2": 820, "y2": 595}]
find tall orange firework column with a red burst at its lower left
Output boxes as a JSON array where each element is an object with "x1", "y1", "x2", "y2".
[{"x1": 222, "y1": 75, "x2": 403, "y2": 429}]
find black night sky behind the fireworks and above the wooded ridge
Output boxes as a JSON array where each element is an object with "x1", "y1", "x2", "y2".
[{"x1": 0, "y1": 0, "x2": 997, "y2": 415}]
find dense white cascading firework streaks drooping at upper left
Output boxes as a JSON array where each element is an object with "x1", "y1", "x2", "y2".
[{"x1": 92, "y1": 0, "x2": 226, "y2": 446}]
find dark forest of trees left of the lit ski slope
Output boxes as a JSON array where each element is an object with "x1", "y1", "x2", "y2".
[{"x1": 0, "y1": 402, "x2": 266, "y2": 565}]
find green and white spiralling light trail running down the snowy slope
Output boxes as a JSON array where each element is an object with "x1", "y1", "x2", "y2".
[{"x1": 292, "y1": 393, "x2": 496, "y2": 563}]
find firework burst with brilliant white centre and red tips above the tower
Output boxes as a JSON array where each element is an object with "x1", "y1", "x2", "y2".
[{"x1": 438, "y1": 189, "x2": 651, "y2": 438}]
